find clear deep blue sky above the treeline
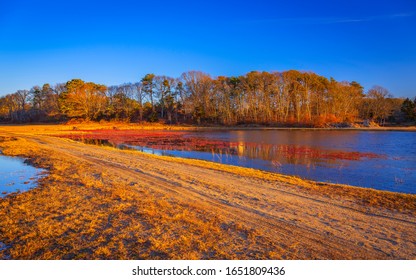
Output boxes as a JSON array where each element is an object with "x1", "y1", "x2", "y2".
[{"x1": 0, "y1": 0, "x2": 416, "y2": 97}]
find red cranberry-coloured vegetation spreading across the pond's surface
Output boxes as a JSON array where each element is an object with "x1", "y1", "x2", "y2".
[{"x1": 59, "y1": 130, "x2": 384, "y2": 161}]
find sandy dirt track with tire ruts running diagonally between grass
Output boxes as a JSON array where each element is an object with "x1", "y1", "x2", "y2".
[{"x1": 4, "y1": 135, "x2": 410, "y2": 259}]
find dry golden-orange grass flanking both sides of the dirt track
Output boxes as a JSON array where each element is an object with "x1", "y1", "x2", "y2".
[{"x1": 0, "y1": 124, "x2": 416, "y2": 259}]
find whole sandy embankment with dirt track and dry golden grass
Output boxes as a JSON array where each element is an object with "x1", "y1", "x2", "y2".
[{"x1": 0, "y1": 127, "x2": 416, "y2": 259}]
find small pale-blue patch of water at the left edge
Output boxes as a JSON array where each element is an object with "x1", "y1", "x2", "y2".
[{"x1": 0, "y1": 155, "x2": 45, "y2": 198}]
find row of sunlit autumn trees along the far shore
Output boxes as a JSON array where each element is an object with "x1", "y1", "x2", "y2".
[{"x1": 0, "y1": 70, "x2": 416, "y2": 126}]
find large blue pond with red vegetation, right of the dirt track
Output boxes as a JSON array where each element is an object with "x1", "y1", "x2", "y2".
[{"x1": 61, "y1": 130, "x2": 416, "y2": 193}]
